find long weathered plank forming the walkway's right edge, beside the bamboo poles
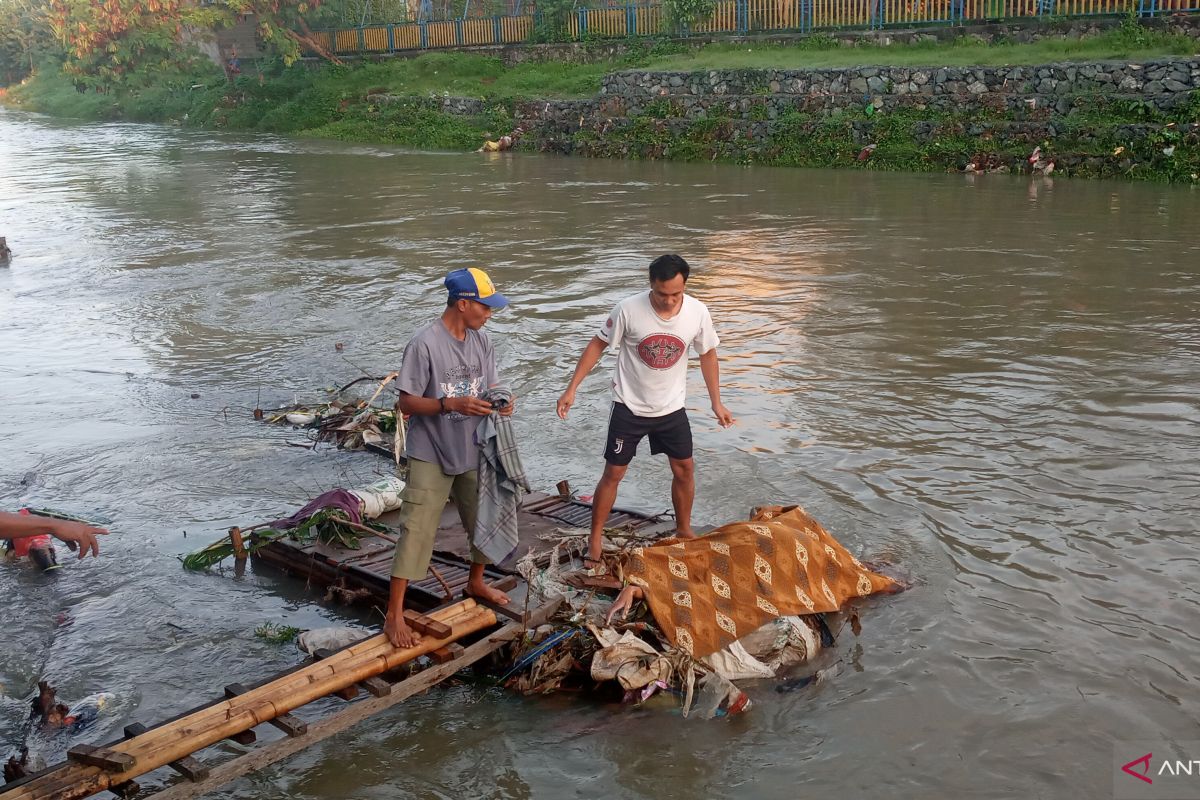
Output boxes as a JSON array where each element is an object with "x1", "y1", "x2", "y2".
[{"x1": 144, "y1": 624, "x2": 523, "y2": 800}]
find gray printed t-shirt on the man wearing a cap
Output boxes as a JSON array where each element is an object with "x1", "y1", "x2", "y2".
[{"x1": 396, "y1": 319, "x2": 499, "y2": 475}]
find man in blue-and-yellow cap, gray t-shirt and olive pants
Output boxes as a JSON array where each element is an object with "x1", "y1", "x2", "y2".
[{"x1": 383, "y1": 267, "x2": 512, "y2": 648}]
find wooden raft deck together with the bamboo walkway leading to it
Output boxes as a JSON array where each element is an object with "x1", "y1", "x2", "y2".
[{"x1": 0, "y1": 483, "x2": 673, "y2": 800}]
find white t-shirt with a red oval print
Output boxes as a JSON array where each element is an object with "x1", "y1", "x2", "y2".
[{"x1": 596, "y1": 290, "x2": 720, "y2": 416}]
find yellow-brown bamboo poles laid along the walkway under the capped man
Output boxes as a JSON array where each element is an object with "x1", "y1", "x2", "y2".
[{"x1": 0, "y1": 599, "x2": 496, "y2": 800}]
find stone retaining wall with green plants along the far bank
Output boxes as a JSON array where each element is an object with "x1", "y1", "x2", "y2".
[{"x1": 376, "y1": 56, "x2": 1200, "y2": 181}]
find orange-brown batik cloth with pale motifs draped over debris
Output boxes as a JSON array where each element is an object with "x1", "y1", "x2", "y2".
[{"x1": 625, "y1": 506, "x2": 900, "y2": 658}]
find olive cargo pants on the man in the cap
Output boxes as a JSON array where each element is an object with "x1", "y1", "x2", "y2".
[{"x1": 391, "y1": 458, "x2": 491, "y2": 581}]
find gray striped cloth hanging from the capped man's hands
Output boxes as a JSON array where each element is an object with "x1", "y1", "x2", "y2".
[{"x1": 474, "y1": 386, "x2": 529, "y2": 564}]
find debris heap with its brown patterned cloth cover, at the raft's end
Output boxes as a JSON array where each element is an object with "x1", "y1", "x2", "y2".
[{"x1": 500, "y1": 507, "x2": 901, "y2": 718}]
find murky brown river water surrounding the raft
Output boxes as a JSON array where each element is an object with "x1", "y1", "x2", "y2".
[{"x1": 0, "y1": 112, "x2": 1200, "y2": 800}]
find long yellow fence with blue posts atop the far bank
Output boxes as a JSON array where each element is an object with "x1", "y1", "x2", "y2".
[{"x1": 316, "y1": 0, "x2": 1200, "y2": 55}]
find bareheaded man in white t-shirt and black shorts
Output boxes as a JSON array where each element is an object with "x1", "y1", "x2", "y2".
[{"x1": 558, "y1": 255, "x2": 733, "y2": 564}]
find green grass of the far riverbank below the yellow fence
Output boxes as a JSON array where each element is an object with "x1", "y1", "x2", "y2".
[{"x1": 5, "y1": 23, "x2": 1200, "y2": 180}]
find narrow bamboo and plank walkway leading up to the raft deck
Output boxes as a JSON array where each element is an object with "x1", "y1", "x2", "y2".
[{"x1": 0, "y1": 599, "x2": 576, "y2": 800}]
